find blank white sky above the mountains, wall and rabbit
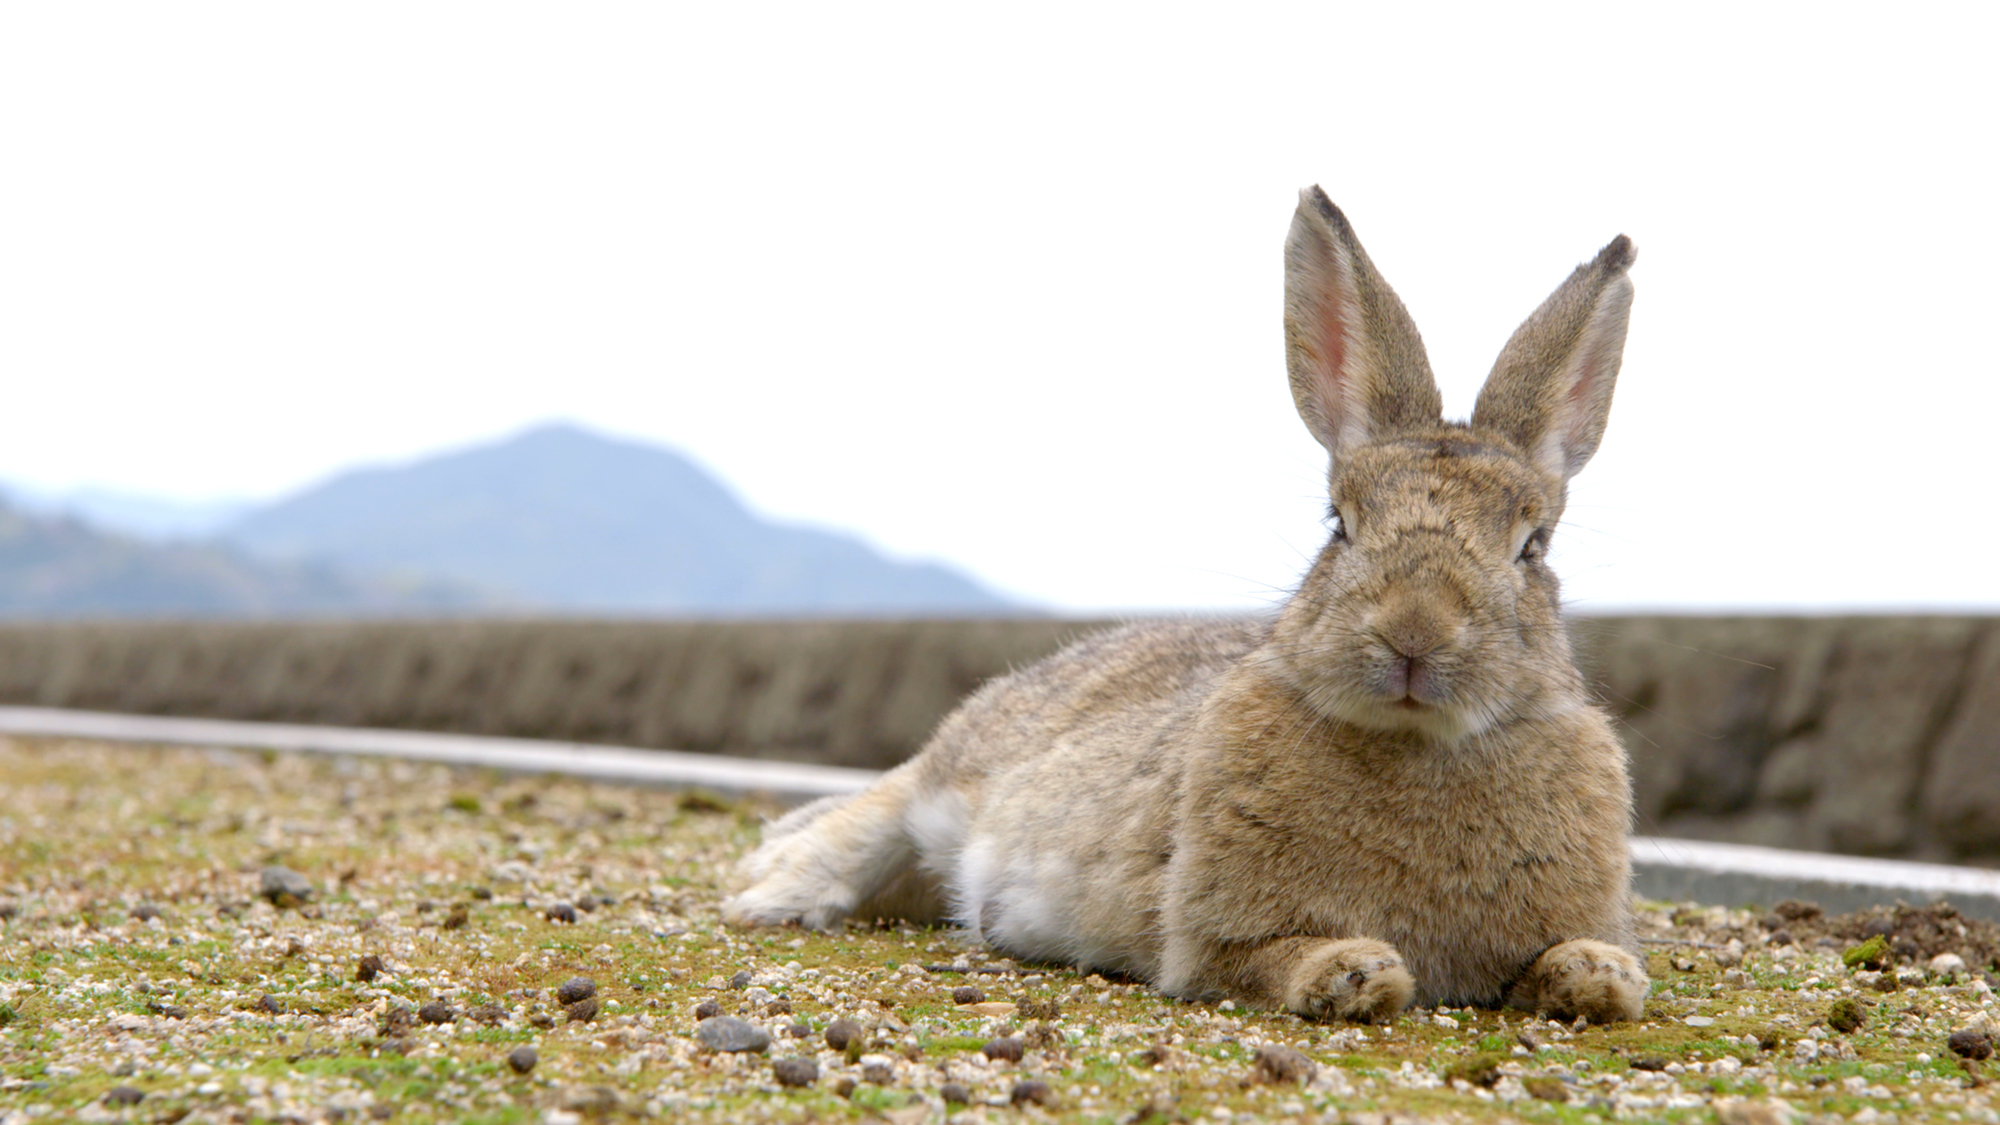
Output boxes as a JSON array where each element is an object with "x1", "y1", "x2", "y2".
[{"x1": 0, "y1": 0, "x2": 2000, "y2": 611}]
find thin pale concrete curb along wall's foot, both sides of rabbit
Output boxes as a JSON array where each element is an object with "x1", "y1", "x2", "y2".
[{"x1": 0, "y1": 707, "x2": 2000, "y2": 921}]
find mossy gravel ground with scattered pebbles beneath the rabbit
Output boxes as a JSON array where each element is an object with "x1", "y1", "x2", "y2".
[{"x1": 0, "y1": 739, "x2": 2000, "y2": 1125}]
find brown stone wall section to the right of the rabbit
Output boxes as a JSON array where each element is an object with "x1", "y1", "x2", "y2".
[{"x1": 1572, "y1": 617, "x2": 2000, "y2": 863}]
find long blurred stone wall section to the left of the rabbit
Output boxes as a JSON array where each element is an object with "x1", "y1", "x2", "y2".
[{"x1": 0, "y1": 619, "x2": 1092, "y2": 769}]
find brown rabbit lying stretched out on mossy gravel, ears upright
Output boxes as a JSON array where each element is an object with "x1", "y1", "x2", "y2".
[{"x1": 722, "y1": 186, "x2": 1650, "y2": 1023}]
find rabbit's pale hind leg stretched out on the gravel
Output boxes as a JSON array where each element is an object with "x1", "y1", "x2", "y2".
[{"x1": 722, "y1": 763, "x2": 964, "y2": 929}]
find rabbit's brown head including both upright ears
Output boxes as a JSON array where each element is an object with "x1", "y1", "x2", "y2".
[{"x1": 1266, "y1": 188, "x2": 1634, "y2": 743}]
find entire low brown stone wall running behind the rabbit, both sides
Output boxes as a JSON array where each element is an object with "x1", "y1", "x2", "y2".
[{"x1": 0, "y1": 617, "x2": 2000, "y2": 865}]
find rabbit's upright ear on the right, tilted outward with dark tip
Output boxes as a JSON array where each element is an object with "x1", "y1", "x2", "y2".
[{"x1": 1472, "y1": 234, "x2": 1638, "y2": 480}]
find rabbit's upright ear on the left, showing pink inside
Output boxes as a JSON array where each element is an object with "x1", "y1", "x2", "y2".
[{"x1": 1284, "y1": 186, "x2": 1444, "y2": 462}]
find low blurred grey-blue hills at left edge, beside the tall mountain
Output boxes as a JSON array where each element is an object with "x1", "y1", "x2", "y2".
[{"x1": 0, "y1": 502, "x2": 484, "y2": 617}]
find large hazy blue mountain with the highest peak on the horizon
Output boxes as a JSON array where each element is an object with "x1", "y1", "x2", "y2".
[{"x1": 220, "y1": 424, "x2": 1014, "y2": 615}]
